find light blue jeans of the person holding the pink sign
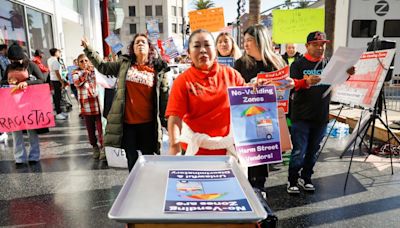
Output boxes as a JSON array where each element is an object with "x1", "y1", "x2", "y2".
[{"x1": 12, "y1": 130, "x2": 40, "y2": 163}]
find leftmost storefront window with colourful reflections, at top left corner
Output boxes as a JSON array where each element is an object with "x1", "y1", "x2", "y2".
[{"x1": 0, "y1": 0, "x2": 27, "y2": 50}]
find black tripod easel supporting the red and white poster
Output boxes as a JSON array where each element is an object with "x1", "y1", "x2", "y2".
[{"x1": 340, "y1": 35, "x2": 400, "y2": 192}]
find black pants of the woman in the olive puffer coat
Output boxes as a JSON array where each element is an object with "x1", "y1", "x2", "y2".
[{"x1": 122, "y1": 122, "x2": 157, "y2": 172}]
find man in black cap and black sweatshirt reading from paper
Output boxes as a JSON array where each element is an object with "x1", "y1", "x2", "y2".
[{"x1": 287, "y1": 31, "x2": 354, "y2": 194}]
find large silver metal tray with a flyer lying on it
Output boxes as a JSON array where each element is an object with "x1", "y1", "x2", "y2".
[{"x1": 108, "y1": 155, "x2": 277, "y2": 228}]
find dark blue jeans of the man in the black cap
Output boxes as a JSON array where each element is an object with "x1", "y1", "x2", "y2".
[{"x1": 288, "y1": 121, "x2": 327, "y2": 182}]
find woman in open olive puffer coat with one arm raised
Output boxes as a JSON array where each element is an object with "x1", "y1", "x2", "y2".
[{"x1": 81, "y1": 33, "x2": 169, "y2": 171}]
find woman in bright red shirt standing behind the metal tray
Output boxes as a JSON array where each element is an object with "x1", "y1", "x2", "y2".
[{"x1": 165, "y1": 29, "x2": 245, "y2": 155}]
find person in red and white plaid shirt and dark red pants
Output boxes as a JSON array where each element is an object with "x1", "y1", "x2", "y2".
[{"x1": 72, "y1": 54, "x2": 106, "y2": 160}]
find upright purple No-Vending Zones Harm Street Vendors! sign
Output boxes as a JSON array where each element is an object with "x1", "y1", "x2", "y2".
[{"x1": 228, "y1": 86, "x2": 282, "y2": 166}]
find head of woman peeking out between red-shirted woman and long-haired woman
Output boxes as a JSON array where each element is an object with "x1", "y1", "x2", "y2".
[{"x1": 216, "y1": 32, "x2": 241, "y2": 60}]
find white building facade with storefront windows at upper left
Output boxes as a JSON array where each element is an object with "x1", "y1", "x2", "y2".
[{"x1": 0, "y1": 0, "x2": 103, "y2": 65}]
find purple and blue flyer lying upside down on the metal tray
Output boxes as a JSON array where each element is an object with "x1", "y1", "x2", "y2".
[{"x1": 164, "y1": 169, "x2": 252, "y2": 213}]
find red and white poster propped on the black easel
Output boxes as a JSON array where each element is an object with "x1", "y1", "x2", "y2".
[{"x1": 332, "y1": 49, "x2": 395, "y2": 108}]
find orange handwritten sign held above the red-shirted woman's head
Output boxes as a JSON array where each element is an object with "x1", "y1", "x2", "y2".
[{"x1": 189, "y1": 7, "x2": 225, "y2": 32}]
